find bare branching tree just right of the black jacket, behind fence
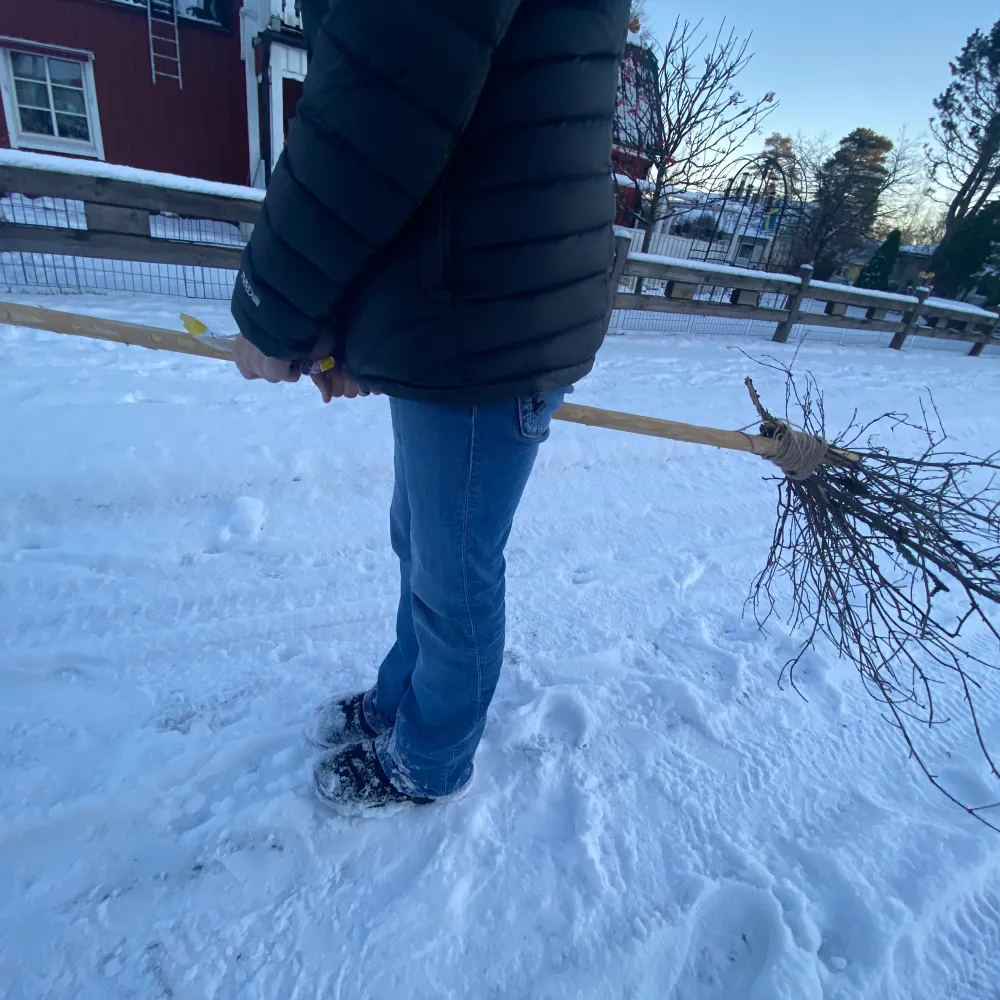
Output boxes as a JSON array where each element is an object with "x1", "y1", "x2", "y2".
[{"x1": 615, "y1": 18, "x2": 776, "y2": 250}]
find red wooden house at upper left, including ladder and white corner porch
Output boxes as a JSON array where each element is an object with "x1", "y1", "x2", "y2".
[{"x1": 0, "y1": 0, "x2": 305, "y2": 186}]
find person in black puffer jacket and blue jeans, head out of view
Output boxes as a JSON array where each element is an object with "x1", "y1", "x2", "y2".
[{"x1": 232, "y1": 0, "x2": 629, "y2": 813}]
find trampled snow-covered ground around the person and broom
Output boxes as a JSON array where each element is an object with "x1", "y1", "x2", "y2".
[{"x1": 0, "y1": 296, "x2": 1000, "y2": 1000}]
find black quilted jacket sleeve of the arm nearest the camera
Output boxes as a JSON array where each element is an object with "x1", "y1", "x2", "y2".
[{"x1": 232, "y1": 0, "x2": 520, "y2": 360}]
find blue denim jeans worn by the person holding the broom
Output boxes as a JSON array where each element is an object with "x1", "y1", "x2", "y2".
[{"x1": 364, "y1": 389, "x2": 568, "y2": 798}]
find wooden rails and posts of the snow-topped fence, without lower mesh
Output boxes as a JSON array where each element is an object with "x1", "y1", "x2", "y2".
[{"x1": 0, "y1": 159, "x2": 1000, "y2": 355}]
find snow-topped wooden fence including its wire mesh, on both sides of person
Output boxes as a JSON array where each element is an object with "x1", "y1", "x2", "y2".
[{"x1": 0, "y1": 151, "x2": 1000, "y2": 355}]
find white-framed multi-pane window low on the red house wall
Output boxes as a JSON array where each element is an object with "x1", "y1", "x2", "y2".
[{"x1": 0, "y1": 49, "x2": 104, "y2": 159}]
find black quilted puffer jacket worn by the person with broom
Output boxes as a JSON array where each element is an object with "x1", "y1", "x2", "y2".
[{"x1": 233, "y1": 0, "x2": 629, "y2": 403}]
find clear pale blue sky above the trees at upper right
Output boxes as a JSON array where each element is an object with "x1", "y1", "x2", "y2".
[{"x1": 646, "y1": 0, "x2": 1000, "y2": 148}]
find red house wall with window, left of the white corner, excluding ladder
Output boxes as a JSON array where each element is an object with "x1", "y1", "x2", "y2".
[{"x1": 0, "y1": 0, "x2": 248, "y2": 184}]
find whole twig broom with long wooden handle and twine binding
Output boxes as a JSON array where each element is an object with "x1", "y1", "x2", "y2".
[{"x1": 0, "y1": 303, "x2": 1000, "y2": 832}]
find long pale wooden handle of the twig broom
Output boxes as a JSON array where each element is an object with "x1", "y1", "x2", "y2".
[{"x1": 0, "y1": 302, "x2": 777, "y2": 457}]
